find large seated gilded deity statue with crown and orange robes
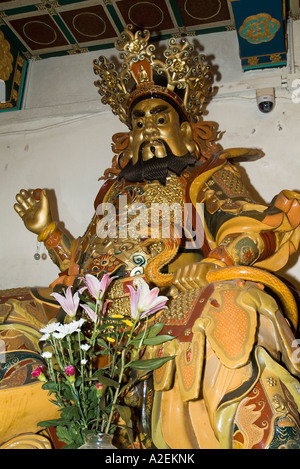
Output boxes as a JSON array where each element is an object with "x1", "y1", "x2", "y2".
[{"x1": 0, "y1": 27, "x2": 300, "y2": 449}]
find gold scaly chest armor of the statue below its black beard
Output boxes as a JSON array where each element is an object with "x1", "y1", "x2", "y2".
[{"x1": 82, "y1": 174, "x2": 188, "y2": 278}]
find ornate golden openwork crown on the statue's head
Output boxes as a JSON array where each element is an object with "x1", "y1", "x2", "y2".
[{"x1": 94, "y1": 25, "x2": 212, "y2": 126}]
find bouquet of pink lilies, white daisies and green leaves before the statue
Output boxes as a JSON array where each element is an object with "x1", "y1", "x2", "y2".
[{"x1": 33, "y1": 274, "x2": 174, "y2": 449}]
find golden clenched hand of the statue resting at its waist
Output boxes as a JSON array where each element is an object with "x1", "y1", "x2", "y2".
[{"x1": 173, "y1": 262, "x2": 218, "y2": 291}]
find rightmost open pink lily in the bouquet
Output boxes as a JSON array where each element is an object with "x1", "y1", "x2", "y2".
[{"x1": 128, "y1": 280, "x2": 168, "y2": 319}]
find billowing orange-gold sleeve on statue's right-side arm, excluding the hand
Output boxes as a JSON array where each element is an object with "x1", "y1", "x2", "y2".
[{"x1": 204, "y1": 190, "x2": 300, "y2": 272}]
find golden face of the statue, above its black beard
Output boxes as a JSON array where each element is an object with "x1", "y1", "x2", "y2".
[{"x1": 128, "y1": 98, "x2": 195, "y2": 164}]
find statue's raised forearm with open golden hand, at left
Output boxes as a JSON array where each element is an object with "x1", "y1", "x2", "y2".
[{"x1": 14, "y1": 189, "x2": 73, "y2": 272}]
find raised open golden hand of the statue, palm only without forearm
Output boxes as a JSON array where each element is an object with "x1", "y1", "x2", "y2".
[{"x1": 14, "y1": 189, "x2": 52, "y2": 235}]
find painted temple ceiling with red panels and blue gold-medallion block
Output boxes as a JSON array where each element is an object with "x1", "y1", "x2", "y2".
[{"x1": 0, "y1": 0, "x2": 300, "y2": 111}]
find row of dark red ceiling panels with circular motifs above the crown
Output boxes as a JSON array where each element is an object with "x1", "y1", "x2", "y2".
[{"x1": 0, "y1": 0, "x2": 238, "y2": 59}]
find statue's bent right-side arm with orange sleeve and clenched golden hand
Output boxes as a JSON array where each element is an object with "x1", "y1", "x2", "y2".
[{"x1": 174, "y1": 163, "x2": 300, "y2": 289}]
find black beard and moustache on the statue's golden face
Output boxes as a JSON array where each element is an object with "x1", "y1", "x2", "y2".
[{"x1": 118, "y1": 142, "x2": 197, "y2": 186}]
